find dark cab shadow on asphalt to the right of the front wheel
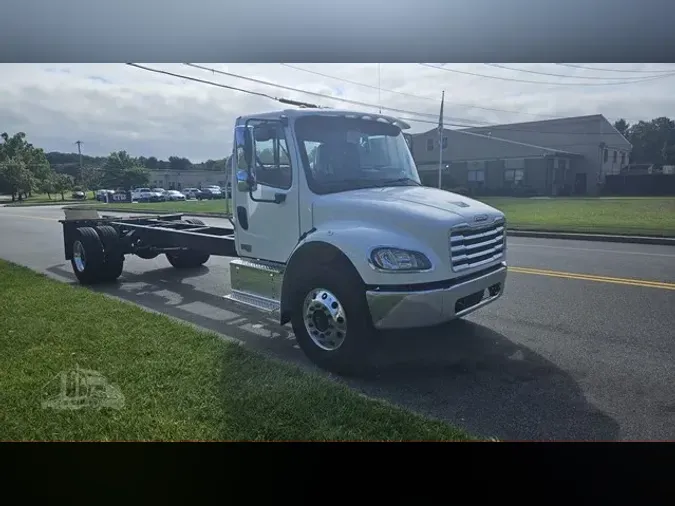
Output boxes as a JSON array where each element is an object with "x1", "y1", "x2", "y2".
[{"x1": 360, "y1": 320, "x2": 620, "y2": 441}]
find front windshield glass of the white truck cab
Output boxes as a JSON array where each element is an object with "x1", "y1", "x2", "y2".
[{"x1": 295, "y1": 116, "x2": 420, "y2": 194}]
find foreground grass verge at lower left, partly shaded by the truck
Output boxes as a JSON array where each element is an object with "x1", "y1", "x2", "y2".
[{"x1": 0, "y1": 261, "x2": 473, "y2": 441}]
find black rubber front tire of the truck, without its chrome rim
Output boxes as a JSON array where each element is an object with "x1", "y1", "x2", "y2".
[{"x1": 291, "y1": 265, "x2": 376, "y2": 376}]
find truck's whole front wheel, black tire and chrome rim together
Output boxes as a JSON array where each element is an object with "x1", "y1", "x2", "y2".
[{"x1": 291, "y1": 267, "x2": 375, "y2": 375}]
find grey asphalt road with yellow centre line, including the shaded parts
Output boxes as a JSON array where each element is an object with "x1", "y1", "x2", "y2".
[{"x1": 0, "y1": 207, "x2": 675, "y2": 440}]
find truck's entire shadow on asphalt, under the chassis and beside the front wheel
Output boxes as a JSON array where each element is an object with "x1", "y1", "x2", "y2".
[{"x1": 47, "y1": 264, "x2": 619, "y2": 441}]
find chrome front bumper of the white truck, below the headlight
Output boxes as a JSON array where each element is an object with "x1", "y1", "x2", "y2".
[{"x1": 366, "y1": 263, "x2": 506, "y2": 329}]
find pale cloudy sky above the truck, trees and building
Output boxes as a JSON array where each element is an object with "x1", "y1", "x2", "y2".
[{"x1": 0, "y1": 63, "x2": 675, "y2": 162}]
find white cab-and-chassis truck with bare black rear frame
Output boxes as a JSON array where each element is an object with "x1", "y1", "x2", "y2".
[{"x1": 61, "y1": 109, "x2": 507, "y2": 374}]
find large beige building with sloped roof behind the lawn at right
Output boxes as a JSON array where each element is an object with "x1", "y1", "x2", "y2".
[{"x1": 410, "y1": 114, "x2": 632, "y2": 196}]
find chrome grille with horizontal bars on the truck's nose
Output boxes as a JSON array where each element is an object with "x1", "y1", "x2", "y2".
[{"x1": 449, "y1": 220, "x2": 506, "y2": 272}]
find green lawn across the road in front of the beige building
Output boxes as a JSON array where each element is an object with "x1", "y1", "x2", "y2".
[{"x1": 480, "y1": 197, "x2": 675, "y2": 237}]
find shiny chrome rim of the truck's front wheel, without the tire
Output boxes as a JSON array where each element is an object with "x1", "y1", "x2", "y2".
[{"x1": 302, "y1": 288, "x2": 347, "y2": 351}]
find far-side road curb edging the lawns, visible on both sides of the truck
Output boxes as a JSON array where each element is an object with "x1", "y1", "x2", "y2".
[{"x1": 64, "y1": 206, "x2": 675, "y2": 246}]
